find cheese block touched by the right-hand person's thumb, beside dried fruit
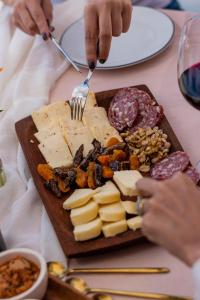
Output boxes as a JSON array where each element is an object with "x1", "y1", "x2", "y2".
[{"x1": 113, "y1": 170, "x2": 142, "y2": 196}]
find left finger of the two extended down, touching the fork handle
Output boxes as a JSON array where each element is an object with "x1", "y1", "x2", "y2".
[{"x1": 84, "y1": 6, "x2": 99, "y2": 70}]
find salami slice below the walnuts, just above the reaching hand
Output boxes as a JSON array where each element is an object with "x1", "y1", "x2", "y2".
[{"x1": 150, "y1": 151, "x2": 189, "y2": 180}]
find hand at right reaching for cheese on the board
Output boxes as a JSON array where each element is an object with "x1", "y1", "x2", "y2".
[{"x1": 137, "y1": 173, "x2": 200, "y2": 266}]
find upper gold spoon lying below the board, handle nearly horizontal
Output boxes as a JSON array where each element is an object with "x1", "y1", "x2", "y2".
[{"x1": 47, "y1": 261, "x2": 170, "y2": 279}]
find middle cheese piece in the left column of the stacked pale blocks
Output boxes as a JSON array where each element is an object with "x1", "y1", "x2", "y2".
[{"x1": 70, "y1": 201, "x2": 99, "y2": 226}]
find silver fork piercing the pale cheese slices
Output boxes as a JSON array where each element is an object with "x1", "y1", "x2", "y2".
[{"x1": 69, "y1": 69, "x2": 95, "y2": 121}]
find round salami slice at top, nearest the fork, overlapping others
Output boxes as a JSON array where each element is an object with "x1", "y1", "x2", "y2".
[{"x1": 108, "y1": 88, "x2": 139, "y2": 131}]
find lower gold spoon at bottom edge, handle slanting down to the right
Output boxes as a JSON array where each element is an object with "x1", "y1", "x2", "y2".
[{"x1": 66, "y1": 277, "x2": 192, "y2": 300}]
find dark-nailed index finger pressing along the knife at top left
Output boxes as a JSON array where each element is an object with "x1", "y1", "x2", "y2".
[{"x1": 26, "y1": 1, "x2": 49, "y2": 40}]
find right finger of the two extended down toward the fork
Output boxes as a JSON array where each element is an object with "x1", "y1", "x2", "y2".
[{"x1": 99, "y1": 9, "x2": 112, "y2": 64}]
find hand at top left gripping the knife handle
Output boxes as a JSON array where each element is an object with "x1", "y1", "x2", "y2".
[{"x1": 12, "y1": 0, "x2": 53, "y2": 40}]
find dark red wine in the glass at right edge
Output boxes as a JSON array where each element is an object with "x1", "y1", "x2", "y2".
[{"x1": 178, "y1": 62, "x2": 200, "y2": 110}]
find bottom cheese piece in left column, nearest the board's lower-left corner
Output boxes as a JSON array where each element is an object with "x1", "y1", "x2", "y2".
[{"x1": 74, "y1": 218, "x2": 102, "y2": 241}]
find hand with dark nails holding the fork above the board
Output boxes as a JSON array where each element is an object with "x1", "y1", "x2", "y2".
[{"x1": 84, "y1": 0, "x2": 132, "y2": 69}]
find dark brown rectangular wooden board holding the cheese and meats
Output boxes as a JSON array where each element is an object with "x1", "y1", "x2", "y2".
[{"x1": 15, "y1": 85, "x2": 183, "y2": 257}]
